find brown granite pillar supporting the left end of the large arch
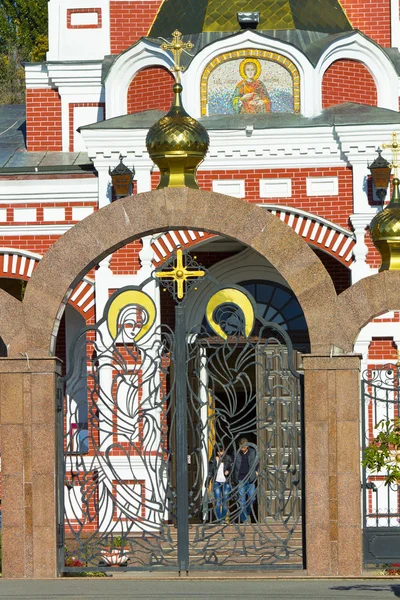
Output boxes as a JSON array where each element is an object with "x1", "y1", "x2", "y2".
[{"x1": 0, "y1": 355, "x2": 60, "y2": 579}]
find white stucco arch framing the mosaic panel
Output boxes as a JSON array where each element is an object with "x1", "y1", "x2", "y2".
[{"x1": 182, "y1": 29, "x2": 318, "y2": 118}]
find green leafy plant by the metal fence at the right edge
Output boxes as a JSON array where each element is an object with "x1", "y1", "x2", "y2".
[{"x1": 362, "y1": 417, "x2": 400, "y2": 485}]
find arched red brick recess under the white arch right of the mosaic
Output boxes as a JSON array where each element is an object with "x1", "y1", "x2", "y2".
[{"x1": 322, "y1": 60, "x2": 378, "y2": 108}]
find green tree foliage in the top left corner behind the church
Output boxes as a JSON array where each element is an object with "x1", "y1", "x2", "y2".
[{"x1": 0, "y1": 0, "x2": 48, "y2": 104}]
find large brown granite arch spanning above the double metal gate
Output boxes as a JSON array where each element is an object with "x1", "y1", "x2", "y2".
[{"x1": 23, "y1": 188, "x2": 336, "y2": 354}]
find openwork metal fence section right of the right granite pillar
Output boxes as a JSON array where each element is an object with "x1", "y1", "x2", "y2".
[{"x1": 361, "y1": 364, "x2": 400, "y2": 564}]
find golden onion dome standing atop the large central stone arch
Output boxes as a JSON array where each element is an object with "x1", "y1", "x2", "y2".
[{"x1": 146, "y1": 83, "x2": 210, "y2": 189}]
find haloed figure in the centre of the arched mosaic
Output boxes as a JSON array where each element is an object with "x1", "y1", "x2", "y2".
[{"x1": 232, "y1": 58, "x2": 271, "y2": 114}]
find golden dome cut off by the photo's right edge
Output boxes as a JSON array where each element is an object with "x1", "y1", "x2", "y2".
[{"x1": 370, "y1": 177, "x2": 400, "y2": 271}]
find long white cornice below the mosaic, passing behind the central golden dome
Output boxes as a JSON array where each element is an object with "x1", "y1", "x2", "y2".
[{"x1": 82, "y1": 119, "x2": 396, "y2": 171}]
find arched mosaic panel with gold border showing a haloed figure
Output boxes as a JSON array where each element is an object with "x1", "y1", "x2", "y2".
[{"x1": 201, "y1": 49, "x2": 300, "y2": 115}]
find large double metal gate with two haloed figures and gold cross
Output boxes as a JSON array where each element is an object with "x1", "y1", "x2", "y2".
[{"x1": 59, "y1": 250, "x2": 304, "y2": 571}]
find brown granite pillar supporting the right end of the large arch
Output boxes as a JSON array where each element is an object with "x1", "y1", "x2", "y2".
[{"x1": 303, "y1": 354, "x2": 362, "y2": 577}]
